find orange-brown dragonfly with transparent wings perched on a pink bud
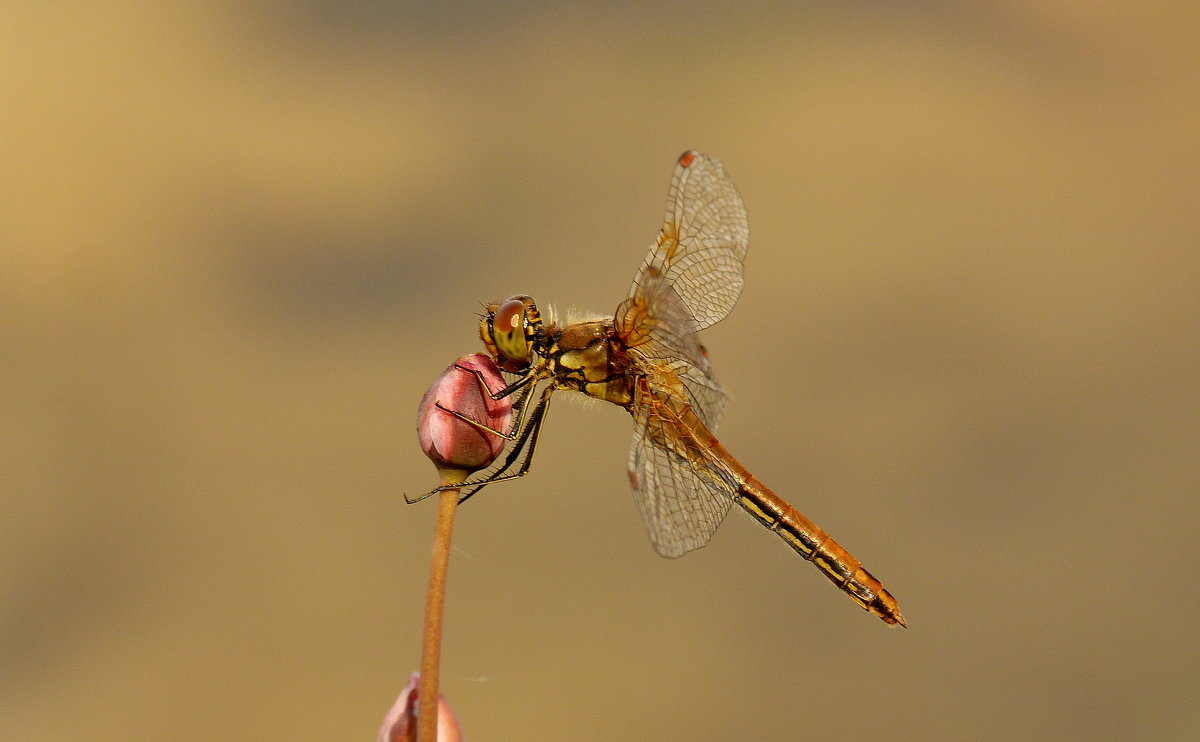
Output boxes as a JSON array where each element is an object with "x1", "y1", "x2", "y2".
[{"x1": 425, "y1": 150, "x2": 906, "y2": 626}]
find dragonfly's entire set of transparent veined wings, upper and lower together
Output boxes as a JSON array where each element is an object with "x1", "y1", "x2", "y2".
[{"x1": 616, "y1": 151, "x2": 750, "y2": 557}]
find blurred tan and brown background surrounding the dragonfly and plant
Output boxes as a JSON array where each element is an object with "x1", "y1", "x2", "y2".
[{"x1": 0, "y1": 0, "x2": 1200, "y2": 742}]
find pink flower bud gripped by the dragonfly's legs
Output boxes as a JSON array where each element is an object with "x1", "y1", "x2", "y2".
[{"x1": 416, "y1": 353, "x2": 512, "y2": 473}]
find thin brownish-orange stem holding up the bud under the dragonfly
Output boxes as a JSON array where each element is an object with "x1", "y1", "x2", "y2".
[{"x1": 416, "y1": 479, "x2": 461, "y2": 742}]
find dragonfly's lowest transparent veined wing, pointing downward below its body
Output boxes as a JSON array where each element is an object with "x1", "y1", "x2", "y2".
[{"x1": 629, "y1": 388, "x2": 738, "y2": 558}]
